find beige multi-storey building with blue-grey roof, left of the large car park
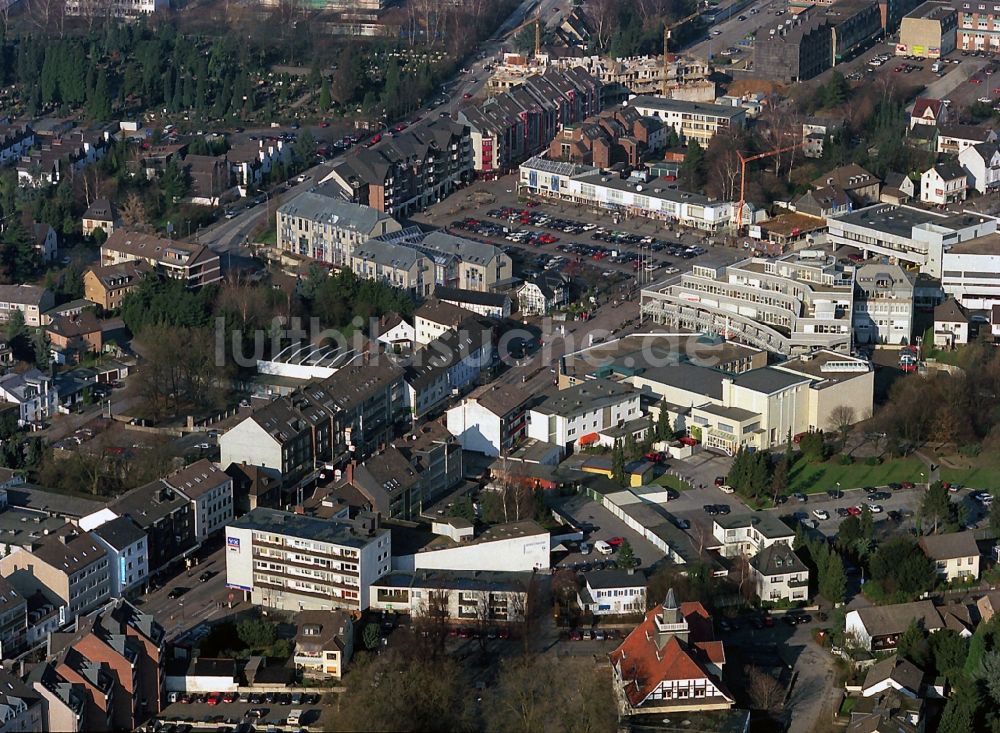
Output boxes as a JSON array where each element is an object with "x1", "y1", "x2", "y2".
[{"x1": 276, "y1": 192, "x2": 401, "y2": 267}]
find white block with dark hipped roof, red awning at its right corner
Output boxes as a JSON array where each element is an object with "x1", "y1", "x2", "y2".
[{"x1": 528, "y1": 379, "x2": 641, "y2": 451}]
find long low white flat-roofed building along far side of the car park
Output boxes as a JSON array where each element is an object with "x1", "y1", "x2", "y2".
[{"x1": 517, "y1": 156, "x2": 755, "y2": 232}]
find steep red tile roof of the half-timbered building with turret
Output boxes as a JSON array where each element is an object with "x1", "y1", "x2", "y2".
[{"x1": 609, "y1": 602, "x2": 726, "y2": 707}]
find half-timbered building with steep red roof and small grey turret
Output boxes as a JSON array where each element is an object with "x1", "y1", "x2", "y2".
[{"x1": 610, "y1": 588, "x2": 733, "y2": 715}]
